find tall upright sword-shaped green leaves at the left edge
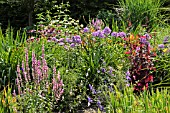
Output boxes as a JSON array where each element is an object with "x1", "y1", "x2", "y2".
[{"x1": 0, "y1": 28, "x2": 26, "y2": 89}]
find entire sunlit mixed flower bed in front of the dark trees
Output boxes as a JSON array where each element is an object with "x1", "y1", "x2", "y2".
[{"x1": 0, "y1": 0, "x2": 170, "y2": 113}]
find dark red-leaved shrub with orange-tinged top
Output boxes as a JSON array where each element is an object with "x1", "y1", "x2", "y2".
[{"x1": 124, "y1": 34, "x2": 156, "y2": 92}]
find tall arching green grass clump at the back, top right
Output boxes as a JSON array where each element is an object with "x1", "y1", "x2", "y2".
[{"x1": 118, "y1": 0, "x2": 164, "y2": 31}]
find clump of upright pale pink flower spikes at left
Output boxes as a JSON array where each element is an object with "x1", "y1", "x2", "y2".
[{"x1": 13, "y1": 46, "x2": 64, "y2": 109}]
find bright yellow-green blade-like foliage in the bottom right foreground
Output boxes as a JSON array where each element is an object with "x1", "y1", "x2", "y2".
[{"x1": 104, "y1": 87, "x2": 170, "y2": 113}]
